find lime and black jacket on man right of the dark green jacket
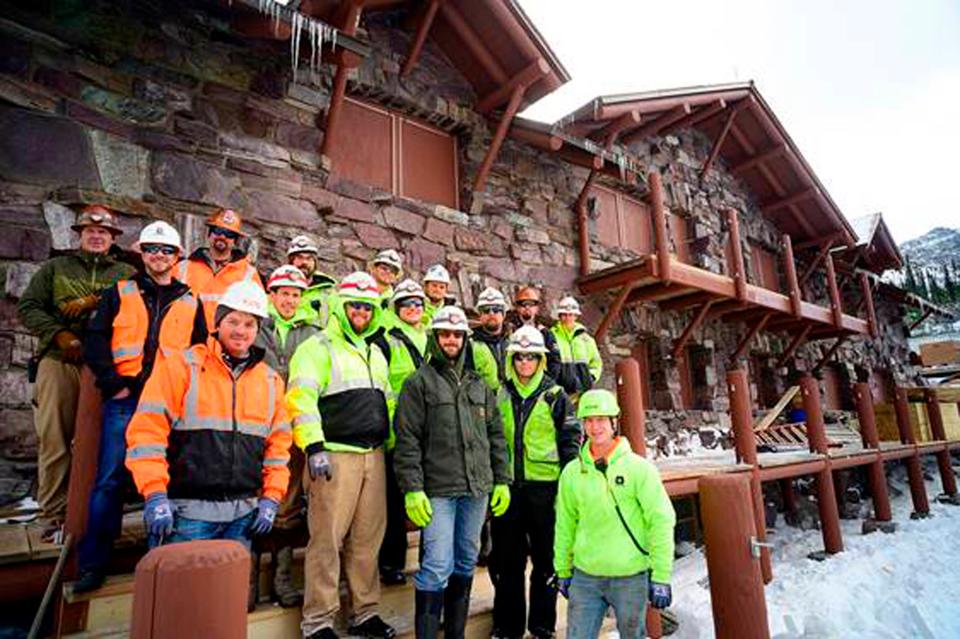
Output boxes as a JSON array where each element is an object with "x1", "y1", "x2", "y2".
[{"x1": 497, "y1": 353, "x2": 580, "y2": 484}]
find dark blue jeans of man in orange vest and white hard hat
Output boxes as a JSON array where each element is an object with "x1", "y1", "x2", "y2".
[{"x1": 77, "y1": 396, "x2": 137, "y2": 572}]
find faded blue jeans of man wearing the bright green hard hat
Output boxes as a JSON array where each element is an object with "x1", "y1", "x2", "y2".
[{"x1": 567, "y1": 569, "x2": 648, "y2": 639}]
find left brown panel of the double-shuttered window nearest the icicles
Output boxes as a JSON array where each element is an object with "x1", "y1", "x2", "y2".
[{"x1": 330, "y1": 98, "x2": 394, "y2": 192}]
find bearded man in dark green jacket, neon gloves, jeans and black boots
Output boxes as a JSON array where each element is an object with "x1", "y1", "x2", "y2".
[{"x1": 394, "y1": 306, "x2": 511, "y2": 639}]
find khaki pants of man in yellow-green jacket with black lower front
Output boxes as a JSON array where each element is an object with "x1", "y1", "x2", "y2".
[{"x1": 300, "y1": 448, "x2": 387, "y2": 637}]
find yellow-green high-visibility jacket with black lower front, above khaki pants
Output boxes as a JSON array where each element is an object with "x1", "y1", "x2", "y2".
[{"x1": 287, "y1": 303, "x2": 391, "y2": 453}]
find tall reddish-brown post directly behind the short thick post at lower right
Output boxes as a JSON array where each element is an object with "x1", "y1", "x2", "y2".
[{"x1": 727, "y1": 368, "x2": 773, "y2": 583}]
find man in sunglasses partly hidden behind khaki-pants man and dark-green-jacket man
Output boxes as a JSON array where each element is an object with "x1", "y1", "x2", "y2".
[{"x1": 375, "y1": 279, "x2": 427, "y2": 585}]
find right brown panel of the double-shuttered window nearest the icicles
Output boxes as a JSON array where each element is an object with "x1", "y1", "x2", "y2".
[{"x1": 399, "y1": 119, "x2": 457, "y2": 208}]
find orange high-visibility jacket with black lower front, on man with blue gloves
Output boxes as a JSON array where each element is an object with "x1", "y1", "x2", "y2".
[{"x1": 126, "y1": 339, "x2": 292, "y2": 502}]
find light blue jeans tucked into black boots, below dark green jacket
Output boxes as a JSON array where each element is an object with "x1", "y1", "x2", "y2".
[{"x1": 413, "y1": 495, "x2": 488, "y2": 592}]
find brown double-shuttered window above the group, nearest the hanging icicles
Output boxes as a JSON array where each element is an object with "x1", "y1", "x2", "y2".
[{"x1": 330, "y1": 98, "x2": 459, "y2": 208}]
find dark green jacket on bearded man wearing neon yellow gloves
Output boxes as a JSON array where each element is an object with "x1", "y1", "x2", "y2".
[{"x1": 393, "y1": 336, "x2": 511, "y2": 497}]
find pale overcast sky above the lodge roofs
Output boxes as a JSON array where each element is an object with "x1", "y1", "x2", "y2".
[{"x1": 519, "y1": 0, "x2": 960, "y2": 242}]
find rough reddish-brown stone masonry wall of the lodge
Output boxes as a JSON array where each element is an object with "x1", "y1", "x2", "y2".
[{"x1": 0, "y1": 0, "x2": 907, "y2": 468}]
